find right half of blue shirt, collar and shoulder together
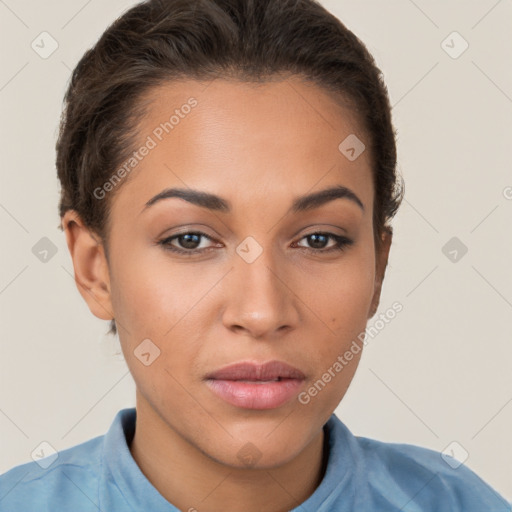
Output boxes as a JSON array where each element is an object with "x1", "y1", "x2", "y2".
[{"x1": 324, "y1": 414, "x2": 512, "y2": 512}]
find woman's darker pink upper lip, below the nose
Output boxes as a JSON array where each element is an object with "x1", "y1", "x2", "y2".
[{"x1": 206, "y1": 361, "x2": 306, "y2": 381}]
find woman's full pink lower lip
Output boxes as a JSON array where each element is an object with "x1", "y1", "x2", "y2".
[{"x1": 206, "y1": 379, "x2": 304, "y2": 409}]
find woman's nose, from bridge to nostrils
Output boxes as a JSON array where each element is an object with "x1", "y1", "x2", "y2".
[{"x1": 222, "y1": 244, "x2": 300, "y2": 339}]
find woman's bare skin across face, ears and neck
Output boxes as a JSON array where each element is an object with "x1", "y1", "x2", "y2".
[{"x1": 62, "y1": 77, "x2": 391, "y2": 512}]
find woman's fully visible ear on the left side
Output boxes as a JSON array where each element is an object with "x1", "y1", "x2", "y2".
[{"x1": 61, "y1": 210, "x2": 114, "y2": 320}]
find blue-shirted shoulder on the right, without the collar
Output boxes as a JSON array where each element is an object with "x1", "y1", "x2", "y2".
[{"x1": 355, "y1": 437, "x2": 512, "y2": 512}]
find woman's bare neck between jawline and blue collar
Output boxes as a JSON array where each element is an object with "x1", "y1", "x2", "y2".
[{"x1": 130, "y1": 394, "x2": 326, "y2": 512}]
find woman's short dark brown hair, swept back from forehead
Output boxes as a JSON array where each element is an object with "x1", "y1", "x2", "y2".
[{"x1": 56, "y1": 0, "x2": 403, "y2": 334}]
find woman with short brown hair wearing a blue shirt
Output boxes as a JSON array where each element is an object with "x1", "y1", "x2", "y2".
[{"x1": 0, "y1": 0, "x2": 510, "y2": 512}]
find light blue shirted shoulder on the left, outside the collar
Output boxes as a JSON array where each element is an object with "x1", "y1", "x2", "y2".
[{"x1": 0, "y1": 436, "x2": 104, "y2": 512}]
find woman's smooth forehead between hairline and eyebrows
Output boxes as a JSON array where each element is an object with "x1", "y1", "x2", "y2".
[{"x1": 110, "y1": 78, "x2": 373, "y2": 217}]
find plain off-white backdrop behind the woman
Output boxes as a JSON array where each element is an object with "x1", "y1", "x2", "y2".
[{"x1": 0, "y1": 0, "x2": 512, "y2": 499}]
